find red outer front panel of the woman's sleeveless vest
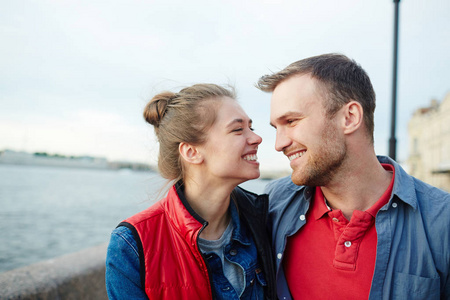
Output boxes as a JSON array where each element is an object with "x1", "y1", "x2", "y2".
[{"x1": 121, "y1": 186, "x2": 212, "y2": 299}]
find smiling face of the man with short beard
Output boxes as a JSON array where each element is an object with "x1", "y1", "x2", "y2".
[{"x1": 270, "y1": 74, "x2": 347, "y2": 186}]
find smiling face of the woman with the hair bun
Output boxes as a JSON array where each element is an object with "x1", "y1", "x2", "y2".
[{"x1": 198, "y1": 97, "x2": 262, "y2": 185}]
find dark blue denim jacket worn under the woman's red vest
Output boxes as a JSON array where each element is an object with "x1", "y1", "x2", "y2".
[{"x1": 105, "y1": 201, "x2": 266, "y2": 299}]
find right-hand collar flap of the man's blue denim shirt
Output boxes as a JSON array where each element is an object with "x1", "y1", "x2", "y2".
[{"x1": 377, "y1": 156, "x2": 417, "y2": 210}]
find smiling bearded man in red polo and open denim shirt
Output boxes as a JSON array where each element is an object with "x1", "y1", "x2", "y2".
[{"x1": 258, "y1": 54, "x2": 450, "y2": 299}]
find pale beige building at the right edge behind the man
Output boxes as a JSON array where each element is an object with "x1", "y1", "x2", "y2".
[{"x1": 407, "y1": 93, "x2": 450, "y2": 191}]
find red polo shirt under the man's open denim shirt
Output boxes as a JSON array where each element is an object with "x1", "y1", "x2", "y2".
[{"x1": 283, "y1": 164, "x2": 395, "y2": 299}]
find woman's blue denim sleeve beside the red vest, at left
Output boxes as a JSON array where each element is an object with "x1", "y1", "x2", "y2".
[{"x1": 105, "y1": 226, "x2": 148, "y2": 299}]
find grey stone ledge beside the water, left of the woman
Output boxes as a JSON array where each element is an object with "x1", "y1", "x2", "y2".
[{"x1": 0, "y1": 244, "x2": 108, "y2": 300}]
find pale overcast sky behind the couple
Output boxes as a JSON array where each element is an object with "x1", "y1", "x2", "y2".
[{"x1": 0, "y1": 0, "x2": 450, "y2": 170}]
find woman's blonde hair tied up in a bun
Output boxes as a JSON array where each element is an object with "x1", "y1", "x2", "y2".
[{"x1": 144, "y1": 83, "x2": 236, "y2": 181}]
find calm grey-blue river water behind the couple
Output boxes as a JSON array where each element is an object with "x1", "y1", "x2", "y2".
[{"x1": 0, "y1": 164, "x2": 267, "y2": 272}]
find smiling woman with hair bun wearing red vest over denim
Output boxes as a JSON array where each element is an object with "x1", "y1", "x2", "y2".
[{"x1": 106, "y1": 84, "x2": 276, "y2": 299}]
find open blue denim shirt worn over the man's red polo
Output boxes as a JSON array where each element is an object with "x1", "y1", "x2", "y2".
[{"x1": 266, "y1": 156, "x2": 450, "y2": 300}]
